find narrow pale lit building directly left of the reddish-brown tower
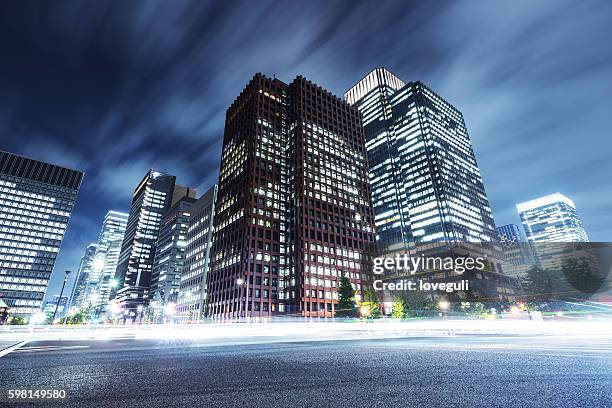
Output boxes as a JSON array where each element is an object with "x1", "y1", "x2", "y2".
[{"x1": 176, "y1": 185, "x2": 217, "y2": 321}]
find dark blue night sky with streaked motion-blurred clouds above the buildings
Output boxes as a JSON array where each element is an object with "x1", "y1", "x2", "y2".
[{"x1": 0, "y1": 0, "x2": 612, "y2": 296}]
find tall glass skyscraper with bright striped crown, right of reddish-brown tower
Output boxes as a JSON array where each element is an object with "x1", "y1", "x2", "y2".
[{"x1": 345, "y1": 68, "x2": 496, "y2": 253}]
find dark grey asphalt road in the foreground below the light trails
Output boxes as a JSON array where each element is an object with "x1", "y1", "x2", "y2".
[{"x1": 0, "y1": 336, "x2": 612, "y2": 408}]
